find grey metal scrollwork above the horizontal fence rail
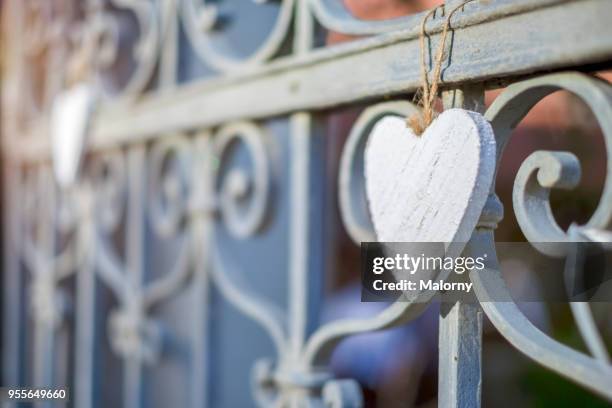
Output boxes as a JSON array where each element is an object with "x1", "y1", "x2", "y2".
[{"x1": 11, "y1": 0, "x2": 554, "y2": 115}]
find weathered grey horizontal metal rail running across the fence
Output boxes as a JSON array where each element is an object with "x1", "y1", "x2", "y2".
[{"x1": 8, "y1": 0, "x2": 612, "y2": 161}]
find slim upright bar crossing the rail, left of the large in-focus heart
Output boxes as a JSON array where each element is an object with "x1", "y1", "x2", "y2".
[{"x1": 289, "y1": 1, "x2": 325, "y2": 406}]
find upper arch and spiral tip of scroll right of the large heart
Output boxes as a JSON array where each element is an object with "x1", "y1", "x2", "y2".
[{"x1": 486, "y1": 73, "x2": 612, "y2": 252}]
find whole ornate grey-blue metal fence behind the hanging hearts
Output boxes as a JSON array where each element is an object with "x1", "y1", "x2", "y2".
[{"x1": 2, "y1": 0, "x2": 612, "y2": 407}]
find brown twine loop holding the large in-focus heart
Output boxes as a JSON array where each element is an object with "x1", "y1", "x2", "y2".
[{"x1": 406, "y1": 0, "x2": 474, "y2": 136}]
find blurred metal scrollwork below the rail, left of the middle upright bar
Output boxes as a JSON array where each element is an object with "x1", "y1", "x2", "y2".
[{"x1": 16, "y1": 122, "x2": 284, "y2": 406}]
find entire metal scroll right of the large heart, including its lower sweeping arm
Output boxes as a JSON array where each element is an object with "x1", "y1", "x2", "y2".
[{"x1": 470, "y1": 73, "x2": 612, "y2": 400}]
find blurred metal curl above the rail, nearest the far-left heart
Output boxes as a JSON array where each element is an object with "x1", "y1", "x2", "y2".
[{"x1": 56, "y1": 0, "x2": 159, "y2": 97}]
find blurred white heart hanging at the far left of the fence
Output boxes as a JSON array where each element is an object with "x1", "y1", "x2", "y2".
[{"x1": 51, "y1": 84, "x2": 95, "y2": 187}]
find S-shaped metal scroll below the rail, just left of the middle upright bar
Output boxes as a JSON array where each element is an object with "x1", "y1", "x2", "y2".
[{"x1": 203, "y1": 122, "x2": 286, "y2": 355}]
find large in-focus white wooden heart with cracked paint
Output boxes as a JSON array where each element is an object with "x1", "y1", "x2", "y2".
[{"x1": 365, "y1": 109, "x2": 496, "y2": 249}]
